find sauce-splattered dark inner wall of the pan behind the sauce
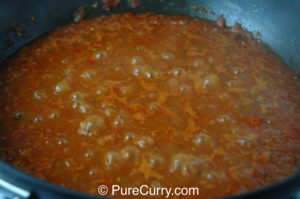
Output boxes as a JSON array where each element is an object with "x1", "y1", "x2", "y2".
[{"x1": 0, "y1": 0, "x2": 300, "y2": 199}]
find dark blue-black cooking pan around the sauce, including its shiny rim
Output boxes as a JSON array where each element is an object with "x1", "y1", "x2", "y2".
[{"x1": 0, "y1": 0, "x2": 300, "y2": 199}]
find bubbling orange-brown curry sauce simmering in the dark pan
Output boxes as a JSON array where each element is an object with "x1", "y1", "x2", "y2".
[{"x1": 0, "y1": 14, "x2": 300, "y2": 198}]
